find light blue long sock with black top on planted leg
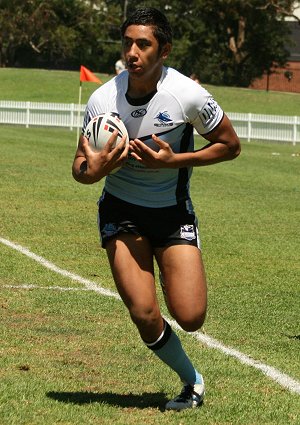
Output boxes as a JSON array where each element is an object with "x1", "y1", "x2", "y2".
[{"x1": 145, "y1": 321, "x2": 202, "y2": 385}]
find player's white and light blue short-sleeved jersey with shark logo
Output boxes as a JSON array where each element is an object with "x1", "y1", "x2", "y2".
[{"x1": 83, "y1": 67, "x2": 223, "y2": 208}]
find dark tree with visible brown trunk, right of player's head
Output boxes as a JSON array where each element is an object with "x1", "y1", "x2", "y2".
[{"x1": 195, "y1": 0, "x2": 292, "y2": 87}]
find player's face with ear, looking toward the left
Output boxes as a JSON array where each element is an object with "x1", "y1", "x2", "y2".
[{"x1": 123, "y1": 25, "x2": 170, "y2": 79}]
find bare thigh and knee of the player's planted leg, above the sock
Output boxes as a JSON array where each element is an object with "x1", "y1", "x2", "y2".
[{"x1": 106, "y1": 233, "x2": 164, "y2": 342}]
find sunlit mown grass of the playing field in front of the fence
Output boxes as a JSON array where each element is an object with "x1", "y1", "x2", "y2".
[{"x1": 0, "y1": 124, "x2": 300, "y2": 425}]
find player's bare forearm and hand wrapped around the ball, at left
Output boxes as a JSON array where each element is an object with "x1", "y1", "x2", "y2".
[{"x1": 72, "y1": 131, "x2": 128, "y2": 184}]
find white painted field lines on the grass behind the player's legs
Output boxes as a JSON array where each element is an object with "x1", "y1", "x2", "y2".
[{"x1": 0, "y1": 237, "x2": 300, "y2": 394}]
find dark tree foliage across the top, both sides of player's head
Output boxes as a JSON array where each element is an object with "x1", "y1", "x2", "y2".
[{"x1": 0, "y1": 0, "x2": 294, "y2": 86}]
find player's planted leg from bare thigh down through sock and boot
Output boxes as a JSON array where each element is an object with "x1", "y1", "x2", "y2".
[{"x1": 106, "y1": 234, "x2": 204, "y2": 410}]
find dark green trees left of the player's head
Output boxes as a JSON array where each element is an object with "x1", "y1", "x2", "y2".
[{"x1": 0, "y1": 0, "x2": 122, "y2": 71}]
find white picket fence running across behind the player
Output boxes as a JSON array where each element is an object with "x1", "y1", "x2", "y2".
[{"x1": 0, "y1": 100, "x2": 300, "y2": 145}]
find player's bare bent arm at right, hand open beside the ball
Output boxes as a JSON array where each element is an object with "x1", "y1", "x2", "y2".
[{"x1": 130, "y1": 115, "x2": 241, "y2": 168}]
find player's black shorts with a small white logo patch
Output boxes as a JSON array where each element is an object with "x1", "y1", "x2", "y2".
[{"x1": 98, "y1": 192, "x2": 200, "y2": 249}]
